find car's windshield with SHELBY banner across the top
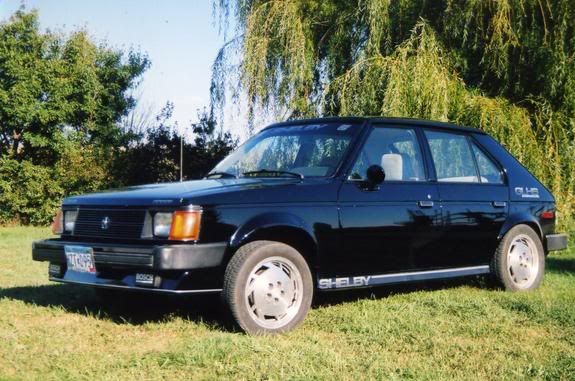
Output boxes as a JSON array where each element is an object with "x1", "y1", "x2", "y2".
[{"x1": 208, "y1": 122, "x2": 359, "y2": 177}]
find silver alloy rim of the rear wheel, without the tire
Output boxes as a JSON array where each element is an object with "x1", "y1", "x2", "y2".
[{"x1": 507, "y1": 234, "x2": 539, "y2": 289}]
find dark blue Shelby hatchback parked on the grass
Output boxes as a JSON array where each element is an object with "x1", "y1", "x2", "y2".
[{"x1": 33, "y1": 118, "x2": 567, "y2": 334}]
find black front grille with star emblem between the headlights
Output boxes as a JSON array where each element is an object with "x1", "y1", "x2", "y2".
[{"x1": 74, "y1": 209, "x2": 146, "y2": 239}]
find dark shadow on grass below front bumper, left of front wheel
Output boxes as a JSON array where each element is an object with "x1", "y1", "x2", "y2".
[{"x1": 0, "y1": 284, "x2": 234, "y2": 331}]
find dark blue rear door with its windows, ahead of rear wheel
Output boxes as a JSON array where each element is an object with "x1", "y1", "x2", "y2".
[{"x1": 424, "y1": 129, "x2": 509, "y2": 267}]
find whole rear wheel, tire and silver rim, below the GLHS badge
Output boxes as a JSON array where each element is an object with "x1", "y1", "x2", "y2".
[{"x1": 491, "y1": 225, "x2": 545, "y2": 291}]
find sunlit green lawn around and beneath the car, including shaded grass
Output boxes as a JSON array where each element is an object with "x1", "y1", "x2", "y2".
[{"x1": 0, "y1": 228, "x2": 575, "y2": 380}]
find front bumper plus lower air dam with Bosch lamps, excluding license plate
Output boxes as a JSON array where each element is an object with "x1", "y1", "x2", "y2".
[{"x1": 32, "y1": 239, "x2": 227, "y2": 294}]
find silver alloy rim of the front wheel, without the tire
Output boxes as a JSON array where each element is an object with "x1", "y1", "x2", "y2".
[{"x1": 245, "y1": 257, "x2": 303, "y2": 329}]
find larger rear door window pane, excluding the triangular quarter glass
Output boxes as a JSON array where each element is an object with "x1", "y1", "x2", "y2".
[{"x1": 425, "y1": 131, "x2": 479, "y2": 183}]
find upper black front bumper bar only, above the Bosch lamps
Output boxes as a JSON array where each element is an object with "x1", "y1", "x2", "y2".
[{"x1": 32, "y1": 239, "x2": 227, "y2": 270}]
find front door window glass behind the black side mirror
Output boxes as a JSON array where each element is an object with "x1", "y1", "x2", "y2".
[{"x1": 349, "y1": 127, "x2": 425, "y2": 181}]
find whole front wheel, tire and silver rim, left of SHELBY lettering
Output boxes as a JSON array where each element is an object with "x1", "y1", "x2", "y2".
[{"x1": 222, "y1": 241, "x2": 313, "y2": 335}]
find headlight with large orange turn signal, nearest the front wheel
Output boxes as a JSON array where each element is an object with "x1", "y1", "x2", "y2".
[{"x1": 154, "y1": 210, "x2": 202, "y2": 241}]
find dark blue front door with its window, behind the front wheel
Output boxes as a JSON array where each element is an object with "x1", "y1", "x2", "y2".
[{"x1": 332, "y1": 125, "x2": 441, "y2": 276}]
